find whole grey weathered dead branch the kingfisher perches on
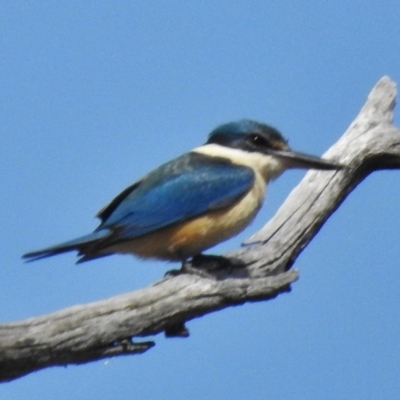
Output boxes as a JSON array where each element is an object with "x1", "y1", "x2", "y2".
[{"x1": 0, "y1": 77, "x2": 400, "y2": 382}]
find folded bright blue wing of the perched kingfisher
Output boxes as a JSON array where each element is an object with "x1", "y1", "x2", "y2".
[{"x1": 97, "y1": 153, "x2": 254, "y2": 241}]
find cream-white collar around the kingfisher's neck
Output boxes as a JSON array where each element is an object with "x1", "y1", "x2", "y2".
[{"x1": 192, "y1": 143, "x2": 285, "y2": 182}]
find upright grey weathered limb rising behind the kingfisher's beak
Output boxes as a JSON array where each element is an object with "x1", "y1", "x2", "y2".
[{"x1": 234, "y1": 77, "x2": 400, "y2": 273}]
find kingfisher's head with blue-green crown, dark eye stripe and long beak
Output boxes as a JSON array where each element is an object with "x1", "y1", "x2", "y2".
[{"x1": 206, "y1": 119, "x2": 343, "y2": 180}]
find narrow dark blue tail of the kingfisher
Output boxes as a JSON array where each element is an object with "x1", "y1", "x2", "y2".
[{"x1": 22, "y1": 230, "x2": 110, "y2": 262}]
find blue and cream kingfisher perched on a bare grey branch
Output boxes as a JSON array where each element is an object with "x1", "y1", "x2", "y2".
[{"x1": 23, "y1": 119, "x2": 343, "y2": 265}]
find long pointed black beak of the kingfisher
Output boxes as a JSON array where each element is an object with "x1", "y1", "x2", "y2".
[{"x1": 273, "y1": 150, "x2": 345, "y2": 170}]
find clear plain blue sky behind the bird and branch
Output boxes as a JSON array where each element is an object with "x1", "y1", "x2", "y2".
[{"x1": 0, "y1": 0, "x2": 400, "y2": 400}]
